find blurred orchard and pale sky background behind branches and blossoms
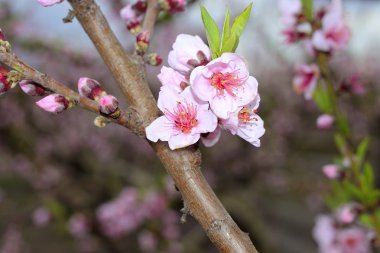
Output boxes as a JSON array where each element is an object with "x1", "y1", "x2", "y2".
[{"x1": 0, "y1": 0, "x2": 380, "y2": 253}]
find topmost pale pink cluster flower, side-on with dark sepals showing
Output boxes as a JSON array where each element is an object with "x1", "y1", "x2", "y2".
[{"x1": 168, "y1": 34, "x2": 211, "y2": 76}]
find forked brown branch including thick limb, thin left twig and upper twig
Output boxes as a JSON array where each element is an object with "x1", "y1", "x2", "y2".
[{"x1": 0, "y1": 0, "x2": 257, "y2": 253}]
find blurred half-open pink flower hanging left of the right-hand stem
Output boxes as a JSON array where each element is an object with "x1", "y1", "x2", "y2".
[{"x1": 293, "y1": 64, "x2": 319, "y2": 99}]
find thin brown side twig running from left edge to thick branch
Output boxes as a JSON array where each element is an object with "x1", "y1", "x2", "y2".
[{"x1": 0, "y1": 52, "x2": 140, "y2": 133}]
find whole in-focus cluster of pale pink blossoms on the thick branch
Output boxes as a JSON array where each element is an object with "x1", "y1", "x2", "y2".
[{"x1": 146, "y1": 34, "x2": 265, "y2": 149}]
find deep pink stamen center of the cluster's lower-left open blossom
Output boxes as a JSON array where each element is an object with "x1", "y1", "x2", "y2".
[{"x1": 165, "y1": 102, "x2": 198, "y2": 134}]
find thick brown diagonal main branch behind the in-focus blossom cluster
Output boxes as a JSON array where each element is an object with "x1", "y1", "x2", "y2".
[{"x1": 60, "y1": 0, "x2": 257, "y2": 253}]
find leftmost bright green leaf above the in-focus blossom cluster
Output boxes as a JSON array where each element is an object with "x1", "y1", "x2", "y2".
[{"x1": 201, "y1": 5, "x2": 220, "y2": 59}]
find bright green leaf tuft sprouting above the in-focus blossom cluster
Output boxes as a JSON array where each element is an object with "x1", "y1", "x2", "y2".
[{"x1": 201, "y1": 3, "x2": 252, "y2": 59}]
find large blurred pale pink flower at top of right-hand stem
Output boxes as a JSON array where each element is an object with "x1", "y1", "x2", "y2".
[{"x1": 312, "y1": 0, "x2": 350, "y2": 52}]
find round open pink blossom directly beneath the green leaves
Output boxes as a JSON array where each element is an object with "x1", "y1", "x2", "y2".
[{"x1": 190, "y1": 53, "x2": 258, "y2": 119}]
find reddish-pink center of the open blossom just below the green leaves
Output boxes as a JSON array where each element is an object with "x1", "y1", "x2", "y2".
[{"x1": 211, "y1": 72, "x2": 244, "y2": 97}]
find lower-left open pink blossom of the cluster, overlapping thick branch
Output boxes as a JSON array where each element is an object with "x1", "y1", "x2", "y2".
[{"x1": 146, "y1": 87, "x2": 217, "y2": 150}]
